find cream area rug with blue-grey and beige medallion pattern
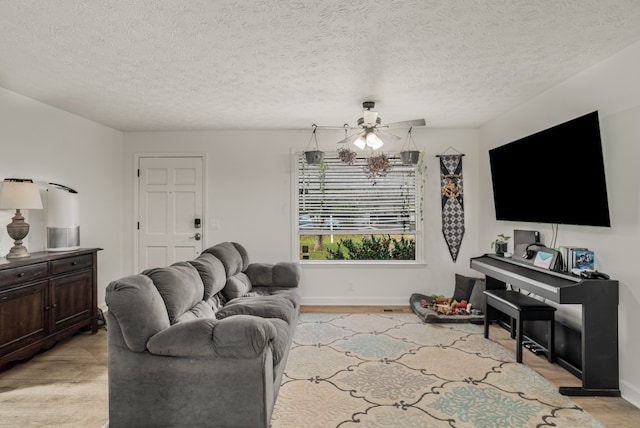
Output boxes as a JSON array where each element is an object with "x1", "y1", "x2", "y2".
[{"x1": 271, "y1": 314, "x2": 603, "y2": 428}]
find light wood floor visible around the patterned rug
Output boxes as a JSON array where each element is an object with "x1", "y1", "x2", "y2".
[{"x1": 0, "y1": 306, "x2": 640, "y2": 428}]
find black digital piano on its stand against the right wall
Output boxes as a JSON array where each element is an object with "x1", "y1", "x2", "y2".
[{"x1": 471, "y1": 254, "x2": 620, "y2": 397}]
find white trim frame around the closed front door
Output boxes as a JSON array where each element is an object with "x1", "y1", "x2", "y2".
[{"x1": 131, "y1": 152, "x2": 209, "y2": 273}]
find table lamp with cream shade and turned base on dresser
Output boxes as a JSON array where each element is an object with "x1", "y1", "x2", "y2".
[{"x1": 0, "y1": 178, "x2": 42, "y2": 259}]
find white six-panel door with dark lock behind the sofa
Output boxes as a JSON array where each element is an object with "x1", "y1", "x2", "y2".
[{"x1": 138, "y1": 157, "x2": 204, "y2": 270}]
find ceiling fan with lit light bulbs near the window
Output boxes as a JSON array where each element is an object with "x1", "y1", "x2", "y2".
[{"x1": 318, "y1": 101, "x2": 426, "y2": 150}]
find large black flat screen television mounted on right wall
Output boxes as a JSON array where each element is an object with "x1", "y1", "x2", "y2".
[{"x1": 489, "y1": 111, "x2": 611, "y2": 227}]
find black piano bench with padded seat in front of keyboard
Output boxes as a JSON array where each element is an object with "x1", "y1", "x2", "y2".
[{"x1": 484, "y1": 290, "x2": 556, "y2": 363}]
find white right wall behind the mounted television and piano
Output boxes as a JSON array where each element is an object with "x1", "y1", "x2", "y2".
[{"x1": 479, "y1": 43, "x2": 640, "y2": 406}]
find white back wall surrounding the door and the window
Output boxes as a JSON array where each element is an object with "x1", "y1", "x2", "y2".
[{"x1": 124, "y1": 129, "x2": 480, "y2": 305}]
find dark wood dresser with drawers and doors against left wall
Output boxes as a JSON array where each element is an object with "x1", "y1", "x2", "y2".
[{"x1": 0, "y1": 248, "x2": 101, "y2": 366}]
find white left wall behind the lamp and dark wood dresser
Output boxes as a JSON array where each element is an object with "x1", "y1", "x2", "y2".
[{"x1": 0, "y1": 88, "x2": 123, "y2": 308}]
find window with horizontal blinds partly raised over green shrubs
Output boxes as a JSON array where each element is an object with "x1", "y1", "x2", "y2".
[{"x1": 295, "y1": 153, "x2": 423, "y2": 261}]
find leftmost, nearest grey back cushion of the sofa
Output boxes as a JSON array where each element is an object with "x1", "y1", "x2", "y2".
[{"x1": 105, "y1": 275, "x2": 170, "y2": 352}]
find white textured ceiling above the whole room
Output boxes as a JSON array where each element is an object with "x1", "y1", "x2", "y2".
[{"x1": 0, "y1": 0, "x2": 640, "y2": 131}]
